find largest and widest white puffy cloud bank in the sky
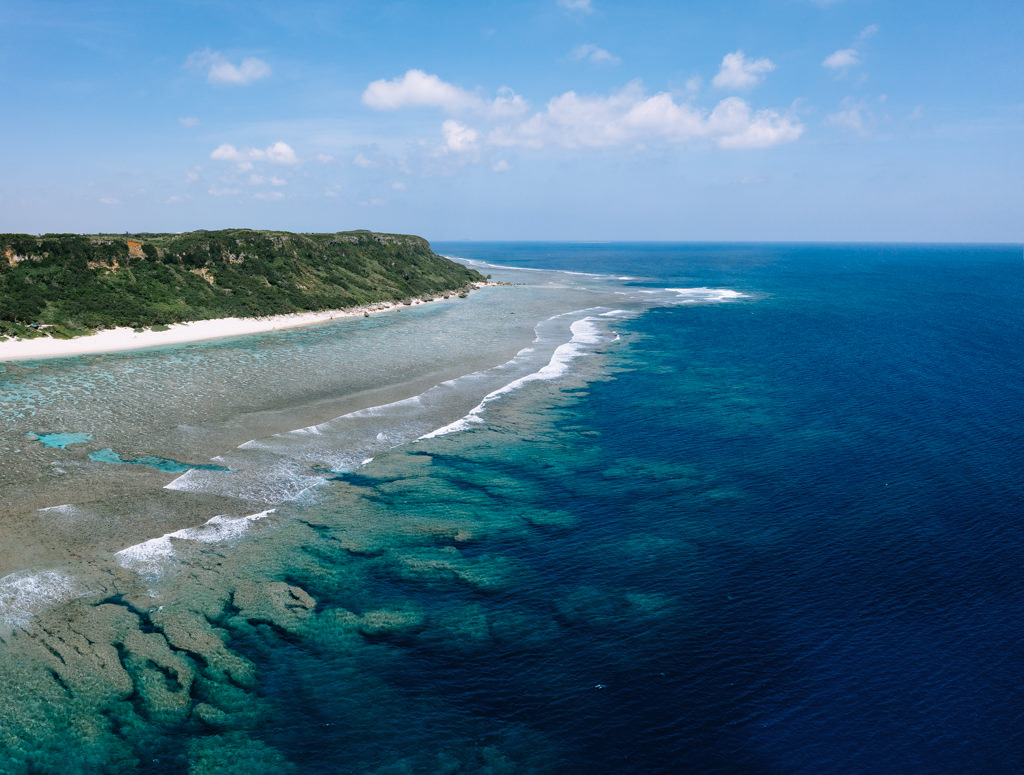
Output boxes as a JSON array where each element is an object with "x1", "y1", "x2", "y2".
[{"x1": 487, "y1": 82, "x2": 804, "y2": 148}]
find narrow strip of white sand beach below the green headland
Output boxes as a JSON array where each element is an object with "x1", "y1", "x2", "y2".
[{"x1": 0, "y1": 283, "x2": 487, "y2": 362}]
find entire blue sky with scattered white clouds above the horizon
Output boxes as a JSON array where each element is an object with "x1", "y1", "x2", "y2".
[{"x1": 0, "y1": 0, "x2": 1024, "y2": 243}]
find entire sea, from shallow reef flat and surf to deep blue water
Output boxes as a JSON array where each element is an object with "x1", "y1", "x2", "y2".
[{"x1": 0, "y1": 243, "x2": 1024, "y2": 775}]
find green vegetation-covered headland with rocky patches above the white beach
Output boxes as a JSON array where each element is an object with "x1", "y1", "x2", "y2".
[{"x1": 0, "y1": 229, "x2": 483, "y2": 337}]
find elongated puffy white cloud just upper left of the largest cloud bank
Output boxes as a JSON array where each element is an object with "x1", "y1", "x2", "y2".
[{"x1": 362, "y1": 70, "x2": 528, "y2": 118}]
